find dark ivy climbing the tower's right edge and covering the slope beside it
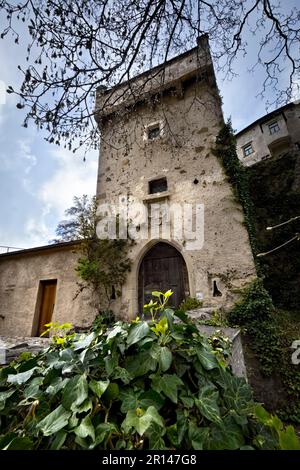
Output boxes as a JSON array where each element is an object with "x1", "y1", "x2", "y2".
[{"x1": 214, "y1": 121, "x2": 300, "y2": 424}]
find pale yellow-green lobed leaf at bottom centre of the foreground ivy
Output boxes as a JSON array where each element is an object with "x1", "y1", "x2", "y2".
[{"x1": 122, "y1": 406, "x2": 164, "y2": 436}]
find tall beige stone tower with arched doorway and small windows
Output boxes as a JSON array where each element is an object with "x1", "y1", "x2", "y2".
[{"x1": 95, "y1": 36, "x2": 255, "y2": 317}]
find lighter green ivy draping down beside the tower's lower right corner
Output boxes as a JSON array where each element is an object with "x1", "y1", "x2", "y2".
[{"x1": 227, "y1": 279, "x2": 300, "y2": 424}]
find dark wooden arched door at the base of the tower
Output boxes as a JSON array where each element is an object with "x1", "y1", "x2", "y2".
[{"x1": 139, "y1": 242, "x2": 189, "y2": 313}]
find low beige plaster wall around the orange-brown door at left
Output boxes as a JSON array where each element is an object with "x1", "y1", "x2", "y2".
[{"x1": 0, "y1": 249, "x2": 95, "y2": 336}]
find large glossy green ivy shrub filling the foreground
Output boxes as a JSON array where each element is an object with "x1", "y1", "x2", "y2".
[{"x1": 0, "y1": 297, "x2": 300, "y2": 449}]
